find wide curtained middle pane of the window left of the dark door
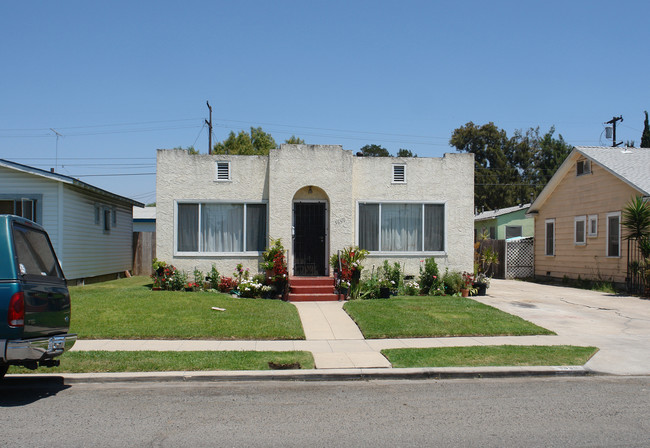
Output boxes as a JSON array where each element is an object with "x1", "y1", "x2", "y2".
[{"x1": 201, "y1": 204, "x2": 244, "y2": 252}]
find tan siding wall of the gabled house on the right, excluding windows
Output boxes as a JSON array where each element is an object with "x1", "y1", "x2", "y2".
[{"x1": 535, "y1": 156, "x2": 639, "y2": 283}]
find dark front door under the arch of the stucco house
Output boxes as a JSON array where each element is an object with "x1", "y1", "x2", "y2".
[{"x1": 293, "y1": 202, "x2": 327, "y2": 276}]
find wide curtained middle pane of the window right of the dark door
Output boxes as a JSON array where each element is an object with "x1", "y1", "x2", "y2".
[{"x1": 381, "y1": 204, "x2": 422, "y2": 252}]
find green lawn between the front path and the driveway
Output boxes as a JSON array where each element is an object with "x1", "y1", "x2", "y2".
[{"x1": 344, "y1": 296, "x2": 555, "y2": 339}]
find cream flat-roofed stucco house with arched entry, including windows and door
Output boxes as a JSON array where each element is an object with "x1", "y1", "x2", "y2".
[{"x1": 156, "y1": 144, "x2": 474, "y2": 276}]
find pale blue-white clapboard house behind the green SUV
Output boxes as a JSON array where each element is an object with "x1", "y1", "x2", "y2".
[{"x1": 0, "y1": 159, "x2": 144, "y2": 283}]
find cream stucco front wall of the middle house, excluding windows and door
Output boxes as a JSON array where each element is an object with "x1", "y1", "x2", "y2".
[{"x1": 156, "y1": 144, "x2": 474, "y2": 275}]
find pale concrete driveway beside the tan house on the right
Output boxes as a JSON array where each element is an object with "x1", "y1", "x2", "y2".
[{"x1": 475, "y1": 280, "x2": 650, "y2": 375}]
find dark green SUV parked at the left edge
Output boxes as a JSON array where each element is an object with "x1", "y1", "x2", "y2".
[{"x1": 0, "y1": 215, "x2": 77, "y2": 378}]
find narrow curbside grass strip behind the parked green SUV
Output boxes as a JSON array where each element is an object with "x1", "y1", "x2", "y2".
[{"x1": 8, "y1": 351, "x2": 314, "y2": 373}]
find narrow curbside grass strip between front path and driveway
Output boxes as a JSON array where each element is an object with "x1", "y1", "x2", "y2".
[{"x1": 381, "y1": 345, "x2": 598, "y2": 367}]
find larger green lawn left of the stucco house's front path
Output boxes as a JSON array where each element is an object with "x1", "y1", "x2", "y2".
[{"x1": 70, "y1": 277, "x2": 305, "y2": 340}]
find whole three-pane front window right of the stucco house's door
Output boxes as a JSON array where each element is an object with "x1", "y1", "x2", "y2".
[{"x1": 359, "y1": 203, "x2": 445, "y2": 252}]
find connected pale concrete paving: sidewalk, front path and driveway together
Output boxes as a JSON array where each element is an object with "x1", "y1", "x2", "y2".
[{"x1": 73, "y1": 280, "x2": 650, "y2": 375}]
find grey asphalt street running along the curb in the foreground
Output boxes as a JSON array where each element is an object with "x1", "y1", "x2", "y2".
[{"x1": 0, "y1": 377, "x2": 650, "y2": 447}]
